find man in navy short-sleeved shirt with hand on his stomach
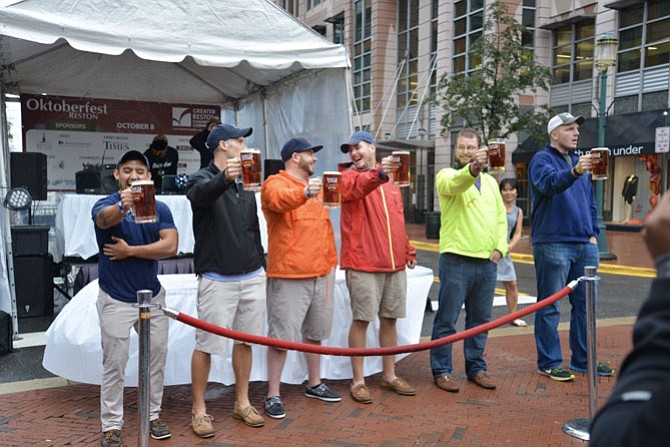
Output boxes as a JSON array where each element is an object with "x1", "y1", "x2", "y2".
[{"x1": 92, "y1": 150, "x2": 178, "y2": 447}]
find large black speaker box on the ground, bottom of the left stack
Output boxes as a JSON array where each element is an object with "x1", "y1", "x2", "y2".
[{"x1": 14, "y1": 254, "x2": 54, "y2": 317}]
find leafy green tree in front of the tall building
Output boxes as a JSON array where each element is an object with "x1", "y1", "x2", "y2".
[{"x1": 436, "y1": 0, "x2": 551, "y2": 144}]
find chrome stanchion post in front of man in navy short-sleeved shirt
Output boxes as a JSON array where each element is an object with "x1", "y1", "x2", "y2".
[{"x1": 135, "y1": 290, "x2": 156, "y2": 447}]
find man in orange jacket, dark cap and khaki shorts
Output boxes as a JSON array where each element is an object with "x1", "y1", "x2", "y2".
[{"x1": 261, "y1": 137, "x2": 342, "y2": 419}]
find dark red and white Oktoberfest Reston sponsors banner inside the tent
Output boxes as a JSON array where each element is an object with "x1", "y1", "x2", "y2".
[{"x1": 21, "y1": 95, "x2": 221, "y2": 191}]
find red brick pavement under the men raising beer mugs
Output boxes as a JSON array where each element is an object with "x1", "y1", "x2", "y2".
[{"x1": 0, "y1": 325, "x2": 631, "y2": 447}]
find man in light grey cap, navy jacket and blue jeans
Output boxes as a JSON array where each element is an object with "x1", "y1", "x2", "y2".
[{"x1": 528, "y1": 112, "x2": 614, "y2": 382}]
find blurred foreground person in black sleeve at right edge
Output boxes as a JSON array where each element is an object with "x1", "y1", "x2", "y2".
[{"x1": 590, "y1": 194, "x2": 670, "y2": 447}]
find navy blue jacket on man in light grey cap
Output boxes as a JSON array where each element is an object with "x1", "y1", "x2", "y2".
[{"x1": 528, "y1": 145, "x2": 598, "y2": 244}]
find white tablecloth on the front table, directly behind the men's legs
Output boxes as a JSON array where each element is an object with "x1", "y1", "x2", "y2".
[{"x1": 43, "y1": 266, "x2": 433, "y2": 386}]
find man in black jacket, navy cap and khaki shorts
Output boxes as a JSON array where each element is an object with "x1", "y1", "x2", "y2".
[{"x1": 186, "y1": 124, "x2": 265, "y2": 438}]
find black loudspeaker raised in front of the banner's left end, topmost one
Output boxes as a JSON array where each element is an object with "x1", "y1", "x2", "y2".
[{"x1": 9, "y1": 152, "x2": 47, "y2": 200}]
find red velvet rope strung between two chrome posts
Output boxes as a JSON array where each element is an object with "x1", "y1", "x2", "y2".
[{"x1": 163, "y1": 281, "x2": 577, "y2": 357}]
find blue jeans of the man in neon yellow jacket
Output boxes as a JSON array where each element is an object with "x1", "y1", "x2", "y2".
[{"x1": 430, "y1": 253, "x2": 497, "y2": 379}]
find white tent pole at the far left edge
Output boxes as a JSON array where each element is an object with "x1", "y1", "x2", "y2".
[{"x1": 0, "y1": 82, "x2": 19, "y2": 340}]
